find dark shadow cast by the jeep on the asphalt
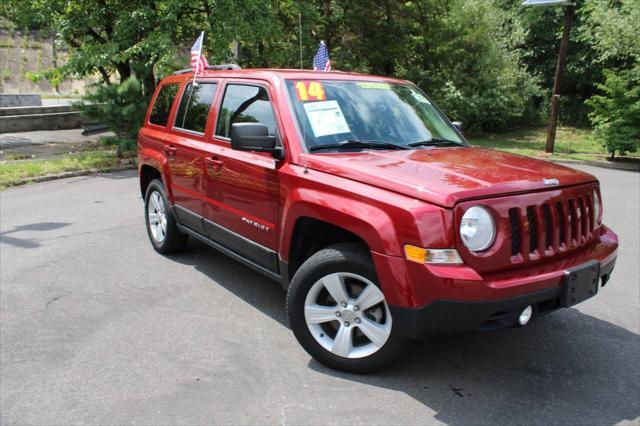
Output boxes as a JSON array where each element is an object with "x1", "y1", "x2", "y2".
[{"x1": 171, "y1": 241, "x2": 640, "y2": 425}]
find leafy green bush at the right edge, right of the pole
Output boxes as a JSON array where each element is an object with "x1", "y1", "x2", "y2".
[{"x1": 588, "y1": 69, "x2": 640, "y2": 158}]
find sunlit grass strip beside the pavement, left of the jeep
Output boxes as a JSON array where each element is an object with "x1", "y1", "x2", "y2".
[{"x1": 0, "y1": 151, "x2": 120, "y2": 190}]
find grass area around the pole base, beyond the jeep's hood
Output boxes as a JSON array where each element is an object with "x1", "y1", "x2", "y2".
[{"x1": 467, "y1": 127, "x2": 639, "y2": 161}]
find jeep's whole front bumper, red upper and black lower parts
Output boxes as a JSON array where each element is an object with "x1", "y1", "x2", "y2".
[{"x1": 373, "y1": 226, "x2": 618, "y2": 339}]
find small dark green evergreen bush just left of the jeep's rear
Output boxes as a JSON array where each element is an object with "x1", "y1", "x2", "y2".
[{"x1": 76, "y1": 77, "x2": 147, "y2": 155}]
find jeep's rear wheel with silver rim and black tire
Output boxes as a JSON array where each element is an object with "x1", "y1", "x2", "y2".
[{"x1": 144, "y1": 179, "x2": 189, "y2": 254}]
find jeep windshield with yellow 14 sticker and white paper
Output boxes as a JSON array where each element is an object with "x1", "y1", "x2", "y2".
[{"x1": 286, "y1": 80, "x2": 467, "y2": 151}]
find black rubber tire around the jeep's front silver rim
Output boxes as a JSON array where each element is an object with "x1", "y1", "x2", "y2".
[{"x1": 287, "y1": 244, "x2": 405, "y2": 373}]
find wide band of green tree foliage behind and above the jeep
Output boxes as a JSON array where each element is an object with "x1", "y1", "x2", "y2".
[{"x1": 0, "y1": 0, "x2": 640, "y2": 143}]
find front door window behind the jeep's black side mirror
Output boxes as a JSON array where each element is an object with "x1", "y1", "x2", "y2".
[{"x1": 216, "y1": 84, "x2": 276, "y2": 138}]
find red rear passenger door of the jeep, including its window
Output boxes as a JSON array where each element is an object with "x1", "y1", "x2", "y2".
[{"x1": 165, "y1": 81, "x2": 218, "y2": 234}]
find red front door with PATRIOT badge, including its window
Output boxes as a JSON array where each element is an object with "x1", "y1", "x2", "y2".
[{"x1": 204, "y1": 81, "x2": 279, "y2": 271}]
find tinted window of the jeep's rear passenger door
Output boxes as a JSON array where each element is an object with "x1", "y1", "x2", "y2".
[{"x1": 175, "y1": 83, "x2": 218, "y2": 133}]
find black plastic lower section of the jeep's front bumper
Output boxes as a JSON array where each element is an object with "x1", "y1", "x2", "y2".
[{"x1": 389, "y1": 258, "x2": 615, "y2": 340}]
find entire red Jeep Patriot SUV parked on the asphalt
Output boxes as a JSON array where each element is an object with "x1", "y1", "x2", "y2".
[{"x1": 138, "y1": 66, "x2": 618, "y2": 373}]
